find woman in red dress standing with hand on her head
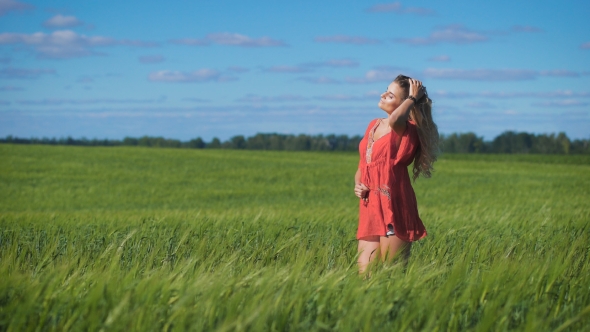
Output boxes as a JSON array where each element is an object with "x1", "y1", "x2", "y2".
[{"x1": 354, "y1": 75, "x2": 438, "y2": 273}]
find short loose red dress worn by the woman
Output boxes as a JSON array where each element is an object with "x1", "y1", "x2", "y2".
[{"x1": 356, "y1": 119, "x2": 426, "y2": 242}]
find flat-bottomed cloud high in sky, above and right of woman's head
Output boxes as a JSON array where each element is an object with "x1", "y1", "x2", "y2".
[{"x1": 394, "y1": 24, "x2": 489, "y2": 45}]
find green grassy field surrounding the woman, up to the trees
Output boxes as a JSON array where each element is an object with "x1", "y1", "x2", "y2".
[{"x1": 0, "y1": 144, "x2": 590, "y2": 331}]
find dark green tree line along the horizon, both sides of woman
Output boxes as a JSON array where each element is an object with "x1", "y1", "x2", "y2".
[{"x1": 0, "y1": 131, "x2": 590, "y2": 154}]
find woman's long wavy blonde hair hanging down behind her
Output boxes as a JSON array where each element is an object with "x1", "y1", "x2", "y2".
[{"x1": 393, "y1": 75, "x2": 440, "y2": 181}]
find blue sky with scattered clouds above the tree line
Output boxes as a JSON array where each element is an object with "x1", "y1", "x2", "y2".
[{"x1": 0, "y1": 0, "x2": 590, "y2": 140}]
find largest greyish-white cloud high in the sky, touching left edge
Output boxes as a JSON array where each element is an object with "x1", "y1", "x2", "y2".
[{"x1": 0, "y1": 30, "x2": 155, "y2": 59}]
